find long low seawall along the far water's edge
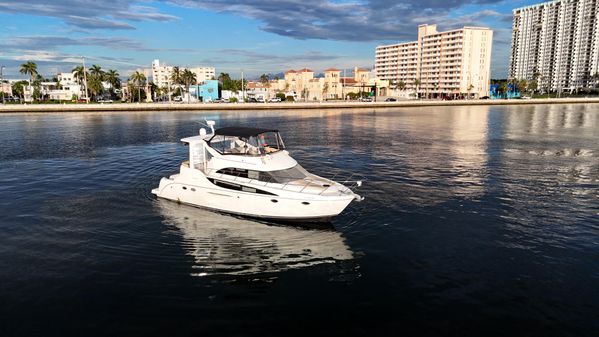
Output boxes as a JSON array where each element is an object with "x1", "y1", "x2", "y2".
[{"x1": 0, "y1": 98, "x2": 599, "y2": 114}]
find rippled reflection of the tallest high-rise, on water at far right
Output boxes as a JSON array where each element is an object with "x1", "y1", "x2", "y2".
[{"x1": 505, "y1": 105, "x2": 599, "y2": 185}]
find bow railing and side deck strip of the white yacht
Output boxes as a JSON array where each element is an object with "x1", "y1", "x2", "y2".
[{"x1": 204, "y1": 168, "x2": 364, "y2": 195}]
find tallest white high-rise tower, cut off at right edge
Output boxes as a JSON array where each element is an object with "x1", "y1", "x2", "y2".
[{"x1": 509, "y1": 0, "x2": 599, "y2": 91}]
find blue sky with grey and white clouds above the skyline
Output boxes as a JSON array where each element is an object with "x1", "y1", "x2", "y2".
[{"x1": 0, "y1": 0, "x2": 540, "y2": 78}]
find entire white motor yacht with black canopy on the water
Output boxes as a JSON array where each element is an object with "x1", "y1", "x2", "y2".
[{"x1": 152, "y1": 121, "x2": 363, "y2": 221}]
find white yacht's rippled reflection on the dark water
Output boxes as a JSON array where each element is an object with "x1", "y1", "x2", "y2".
[{"x1": 156, "y1": 200, "x2": 353, "y2": 276}]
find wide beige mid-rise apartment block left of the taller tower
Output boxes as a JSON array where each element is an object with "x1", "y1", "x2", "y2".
[{"x1": 375, "y1": 25, "x2": 493, "y2": 98}]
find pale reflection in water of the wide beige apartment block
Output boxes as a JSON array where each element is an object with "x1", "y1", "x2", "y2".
[{"x1": 373, "y1": 106, "x2": 489, "y2": 206}]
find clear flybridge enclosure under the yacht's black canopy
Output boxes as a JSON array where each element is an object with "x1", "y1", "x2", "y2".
[{"x1": 208, "y1": 131, "x2": 285, "y2": 156}]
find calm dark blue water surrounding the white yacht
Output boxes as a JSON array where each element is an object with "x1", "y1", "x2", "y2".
[{"x1": 0, "y1": 105, "x2": 599, "y2": 337}]
